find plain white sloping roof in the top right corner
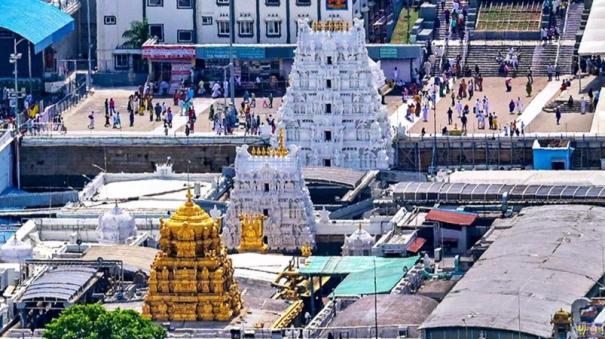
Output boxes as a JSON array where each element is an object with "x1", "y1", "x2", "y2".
[{"x1": 578, "y1": 0, "x2": 605, "y2": 55}]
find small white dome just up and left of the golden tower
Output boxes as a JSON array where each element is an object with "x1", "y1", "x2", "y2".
[{"x1": 97, "y1": 204, "x2": 137, "y2": 244}]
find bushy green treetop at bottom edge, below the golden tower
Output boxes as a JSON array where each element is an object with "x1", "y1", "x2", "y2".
[{"x1": 44, "y1": 304, "x2": 166, "y2": 339}]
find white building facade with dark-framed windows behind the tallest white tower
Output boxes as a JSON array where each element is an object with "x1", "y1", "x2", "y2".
[{"x1": 96, "y1": 0, "x2": 353, "y2": 72}]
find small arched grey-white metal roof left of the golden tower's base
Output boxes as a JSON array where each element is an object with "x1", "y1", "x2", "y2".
[{"x1": 19, "y1": 266, "x2": 97, "y2": 302}]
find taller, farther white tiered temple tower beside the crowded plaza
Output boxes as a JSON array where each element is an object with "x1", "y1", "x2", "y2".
[{"x1": 280, "y1": 19, "x2": 393, "y2": 170}]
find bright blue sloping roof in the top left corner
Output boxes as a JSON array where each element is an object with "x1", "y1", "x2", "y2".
[{"x1": 0, "y1": 0, "x2": 75, "y2": 53}]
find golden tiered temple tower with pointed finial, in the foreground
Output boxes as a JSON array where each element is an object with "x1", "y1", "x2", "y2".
[{"x1": 143, "y1": 190, "x2": 242, "y2": 321}]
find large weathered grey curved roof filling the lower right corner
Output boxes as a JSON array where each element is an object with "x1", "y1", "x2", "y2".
[{"x1": 422, "y1": 205, "x2": 605, "y2": 338}]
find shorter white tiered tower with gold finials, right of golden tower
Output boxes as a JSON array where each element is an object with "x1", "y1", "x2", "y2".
[{"x1": 222, "y1": 130, "x2": 315, "y2": 252}]
